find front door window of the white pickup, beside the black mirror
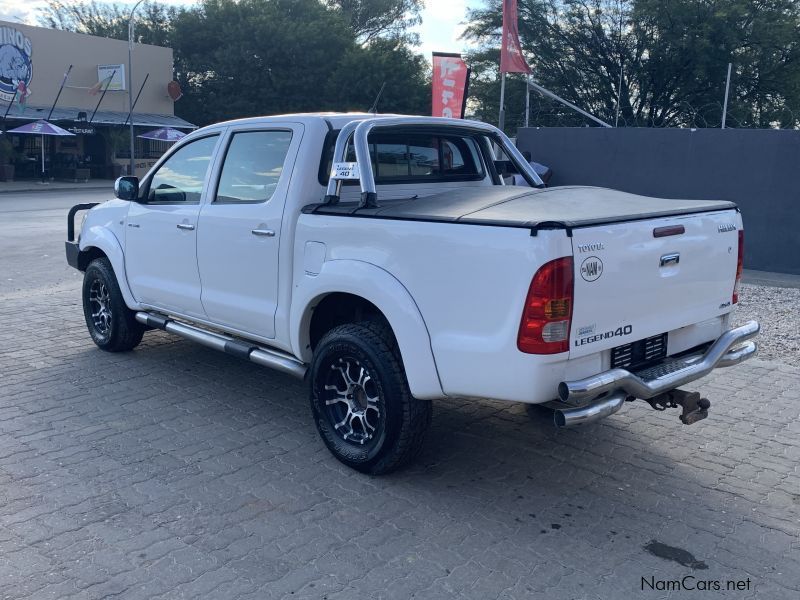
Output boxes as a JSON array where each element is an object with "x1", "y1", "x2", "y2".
[{"x1": 147, "y1": 135, "x2": 219, "y2": 204}]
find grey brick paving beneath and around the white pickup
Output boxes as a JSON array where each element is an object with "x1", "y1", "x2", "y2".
[{"x1": 0, "y1": 191, "x2": 800, "y2": 600}]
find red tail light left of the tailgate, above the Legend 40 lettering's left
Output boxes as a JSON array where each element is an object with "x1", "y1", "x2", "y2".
[{"x1": 517, "y1": 256, "x2": 573, "y2": 354}]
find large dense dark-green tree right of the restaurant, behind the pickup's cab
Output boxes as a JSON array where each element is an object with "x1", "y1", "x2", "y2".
[{"x1": 172, "y1": 0, "x2": 352, "y2": 124}]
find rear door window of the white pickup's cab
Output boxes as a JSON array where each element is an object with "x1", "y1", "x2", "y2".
[{"x1": 214, "y1": 131, "x2": 292, "y2": 204}]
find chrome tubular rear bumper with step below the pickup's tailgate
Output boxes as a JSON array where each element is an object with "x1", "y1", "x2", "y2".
[{"x1": 558, "y1": 321, "x2": 760, "y2": 406}]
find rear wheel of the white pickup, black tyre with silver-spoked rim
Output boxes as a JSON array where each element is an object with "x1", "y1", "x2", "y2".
[{"x1": 310, "y1": 322, "x2": 431, "y2": 475}]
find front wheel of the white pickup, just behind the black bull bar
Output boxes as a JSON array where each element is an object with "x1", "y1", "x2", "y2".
[{"x1": 83, "y1": 258, "x2": 145, "y2": 352}]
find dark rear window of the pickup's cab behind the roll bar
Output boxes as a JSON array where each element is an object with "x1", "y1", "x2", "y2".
[{"x1": 319, "y1": 131, "x2": 485, "y2": 185}]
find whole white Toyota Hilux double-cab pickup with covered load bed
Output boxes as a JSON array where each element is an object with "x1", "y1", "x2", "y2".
[{"x1": 66, "y1": 114, "x2": 759, "y2": 474}]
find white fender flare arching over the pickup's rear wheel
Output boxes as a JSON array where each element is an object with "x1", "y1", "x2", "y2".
[{"x1": 289, "y1": 259, "x2": 444, "y2": 399}]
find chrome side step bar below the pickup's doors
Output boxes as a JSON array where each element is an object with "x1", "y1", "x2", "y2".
[{"x1": 136, "y1": 312, "x2": 307, "y2": 379}]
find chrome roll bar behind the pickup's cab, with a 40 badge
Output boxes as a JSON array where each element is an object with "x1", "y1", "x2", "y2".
[{"x1": 325, "y1": 117, "x2": 544, "y2": 208}]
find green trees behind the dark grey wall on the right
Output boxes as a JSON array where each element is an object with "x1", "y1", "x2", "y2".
[{"x1": 466, "y1": 0, "x2": 800, "y2": 127}]
